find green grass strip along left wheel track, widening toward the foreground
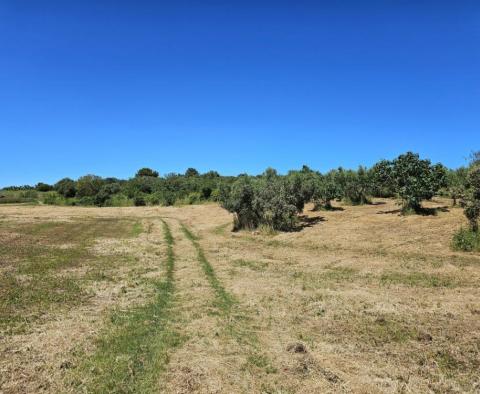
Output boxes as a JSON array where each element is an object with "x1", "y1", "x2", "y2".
[{"x1": 73, "y1": 222, "x2": 181, "y2": 393}]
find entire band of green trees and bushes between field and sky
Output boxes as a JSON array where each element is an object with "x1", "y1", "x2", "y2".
[{"x1": 0, "y1": 152, "x2": 480, "y2": 249}]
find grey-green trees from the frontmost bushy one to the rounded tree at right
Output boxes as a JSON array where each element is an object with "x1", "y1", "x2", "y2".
[{"x1": 220, "y1": 152, "x2": 448, "y2": 230}]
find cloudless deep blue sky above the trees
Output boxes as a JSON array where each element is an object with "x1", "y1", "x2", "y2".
[{"x1": 0, "y1": 0, "x2": 480, "y2": 186}]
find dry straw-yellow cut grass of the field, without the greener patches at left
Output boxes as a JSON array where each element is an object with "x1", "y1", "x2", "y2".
[{"x1": 0, "y1": 200, "x2": 480, "y2": 393}]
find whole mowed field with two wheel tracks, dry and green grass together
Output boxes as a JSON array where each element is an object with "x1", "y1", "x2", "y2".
[{"x1": 0, "y1": 200, "x2": 480, "y2": 393}]
